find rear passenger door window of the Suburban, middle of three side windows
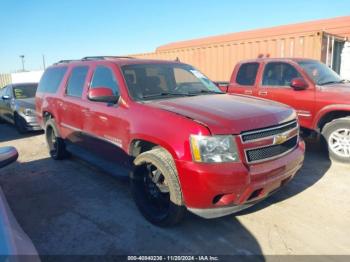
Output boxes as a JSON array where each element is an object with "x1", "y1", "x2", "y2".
[{"x1": 66, "y1": 66, "x2": 89, "y2": 97}]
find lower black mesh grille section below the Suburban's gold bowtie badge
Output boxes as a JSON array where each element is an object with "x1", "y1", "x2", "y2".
[{"x1": 246, "y1": 136, "x2": 298, "y2": 162}]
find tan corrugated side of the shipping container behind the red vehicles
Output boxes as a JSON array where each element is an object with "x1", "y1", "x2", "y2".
[{"x1": 131, "y1": 31, "x2": 323, "y2": 81}]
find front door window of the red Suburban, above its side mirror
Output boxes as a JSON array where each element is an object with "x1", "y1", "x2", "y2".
[{"x1": 90, "y1": 66, "x2": 119, "y2": 95}]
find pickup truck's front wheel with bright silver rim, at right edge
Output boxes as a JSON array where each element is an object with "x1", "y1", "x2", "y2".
[{"x1": 322, "y1": 117, "x2": 350, "y2": 164}]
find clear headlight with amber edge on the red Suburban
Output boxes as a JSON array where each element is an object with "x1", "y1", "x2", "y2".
[{"x1": 190, "y1": 135, "x2": 239, "y2": 163}]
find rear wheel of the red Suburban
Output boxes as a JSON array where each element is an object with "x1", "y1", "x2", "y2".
[{"x1": 45, "y1": 119, "x2": 69, "y2": 160}]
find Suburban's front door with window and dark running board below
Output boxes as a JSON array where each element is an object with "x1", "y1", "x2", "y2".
[{"x1": 84, "y1": 66, "x2": 129, "y2": 168}]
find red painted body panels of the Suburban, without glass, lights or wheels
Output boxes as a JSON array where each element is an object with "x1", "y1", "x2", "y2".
[{"x1": 36, "y1": 59, "x2": 305, "y2": 211}]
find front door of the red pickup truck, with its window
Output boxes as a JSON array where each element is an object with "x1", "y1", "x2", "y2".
[{"x1": 257, "y1": 61, "x2": 315, "y2": 126}]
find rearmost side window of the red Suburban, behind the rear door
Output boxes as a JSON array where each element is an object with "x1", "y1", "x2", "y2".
[{"x1": 38, "y1": 67, "x2": 67, "y2": 93}]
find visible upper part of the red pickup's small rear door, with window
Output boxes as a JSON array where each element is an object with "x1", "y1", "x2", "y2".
[{"x1": 228, "y1": 62, "x2": 260, "y2": 96}]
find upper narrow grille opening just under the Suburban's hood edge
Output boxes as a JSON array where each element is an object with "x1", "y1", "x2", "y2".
[{"x1": 241, "y1": 120, "x2": 298, "y2": 142}]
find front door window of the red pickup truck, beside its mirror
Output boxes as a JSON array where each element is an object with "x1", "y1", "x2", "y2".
[{"x1": 262, "y1": 62, "x2": 301, "y2": 86}]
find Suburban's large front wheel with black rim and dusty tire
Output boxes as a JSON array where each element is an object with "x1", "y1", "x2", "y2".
[{"x1": 131, "y1": 148, "x2": 186, "y2": 227}]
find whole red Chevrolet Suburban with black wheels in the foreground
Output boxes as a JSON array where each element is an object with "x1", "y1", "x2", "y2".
[{"x1": 36, "y1": 56, "x2": 305, "y2": 226}]
